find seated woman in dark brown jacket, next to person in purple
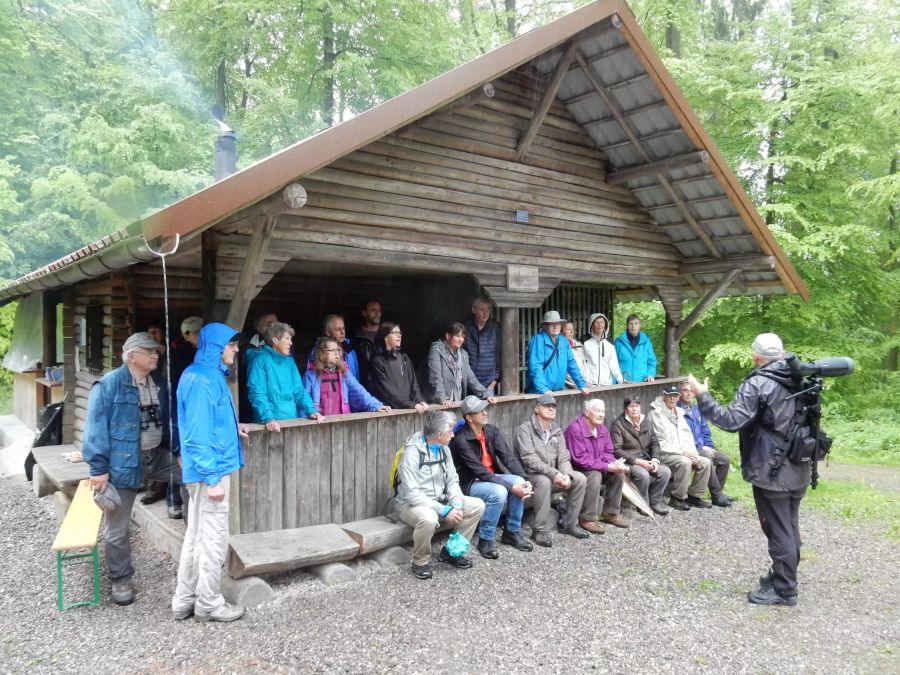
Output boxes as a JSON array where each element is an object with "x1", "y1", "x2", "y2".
[{"x1": 610, "y1": 396, "x2": 672, "y2": 516}]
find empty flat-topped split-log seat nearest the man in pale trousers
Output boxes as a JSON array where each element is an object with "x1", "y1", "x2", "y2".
[{"x1": 227, "y1": 525, "x2": 359, "y2": 579}]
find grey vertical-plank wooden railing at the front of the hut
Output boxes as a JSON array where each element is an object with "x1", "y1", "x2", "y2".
[{"x1": 231, "y1": 380, "x2": 672, "y2": 532}]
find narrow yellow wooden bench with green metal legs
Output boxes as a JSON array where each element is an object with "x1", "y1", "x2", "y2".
[{"x1": 51, "y1": 480, "x2": 103, "y2": 611}]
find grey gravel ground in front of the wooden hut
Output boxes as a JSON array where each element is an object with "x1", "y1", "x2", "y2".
[{"x1": 0, "y1": 477, "x2": 900, "y2": 673}]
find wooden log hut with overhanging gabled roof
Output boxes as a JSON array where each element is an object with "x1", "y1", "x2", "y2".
[{"x1": 0, "y1": 0, "x2": 807, "y2": 532}]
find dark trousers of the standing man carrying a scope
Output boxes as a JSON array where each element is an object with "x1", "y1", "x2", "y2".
[{"x1": 753, "y1": 485, "x2": 806, "y2": 598}]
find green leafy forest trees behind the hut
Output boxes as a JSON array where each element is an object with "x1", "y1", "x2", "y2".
[{"x1": 0, "y1": 0, "x2": 900, "y2": 465}]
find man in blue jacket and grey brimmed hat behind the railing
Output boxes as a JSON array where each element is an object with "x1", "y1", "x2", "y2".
[{"x1": 527, "y1": 311, "x2": 588, "y2": 394}]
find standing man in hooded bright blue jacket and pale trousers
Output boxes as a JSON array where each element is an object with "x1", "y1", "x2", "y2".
[{"x1": 172, "y1": 323, "x2": 247, "y2": 622}]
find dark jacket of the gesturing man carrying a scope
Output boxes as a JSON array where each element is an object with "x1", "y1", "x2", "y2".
[{"x1": 697, "y1": 359, "x2": 810, "y2": 492}]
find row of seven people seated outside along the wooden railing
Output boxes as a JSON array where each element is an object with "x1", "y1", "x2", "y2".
[{"x1": 395, "y1": 383, "x2": 731, "y2": 579}]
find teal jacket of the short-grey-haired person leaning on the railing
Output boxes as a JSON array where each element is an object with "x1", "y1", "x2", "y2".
[{"x1": 247, "y1": 345, "x2": 319, "y2": 424}]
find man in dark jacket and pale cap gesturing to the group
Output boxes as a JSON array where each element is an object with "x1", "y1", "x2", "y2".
[{"x1": 688, "y1": 333, "x2": 810, "y2": 605}]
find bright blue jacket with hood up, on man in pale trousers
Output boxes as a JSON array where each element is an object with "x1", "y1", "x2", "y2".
[{"x1": 177, "y1": 323, "x2": 244, "y2": 486}]
